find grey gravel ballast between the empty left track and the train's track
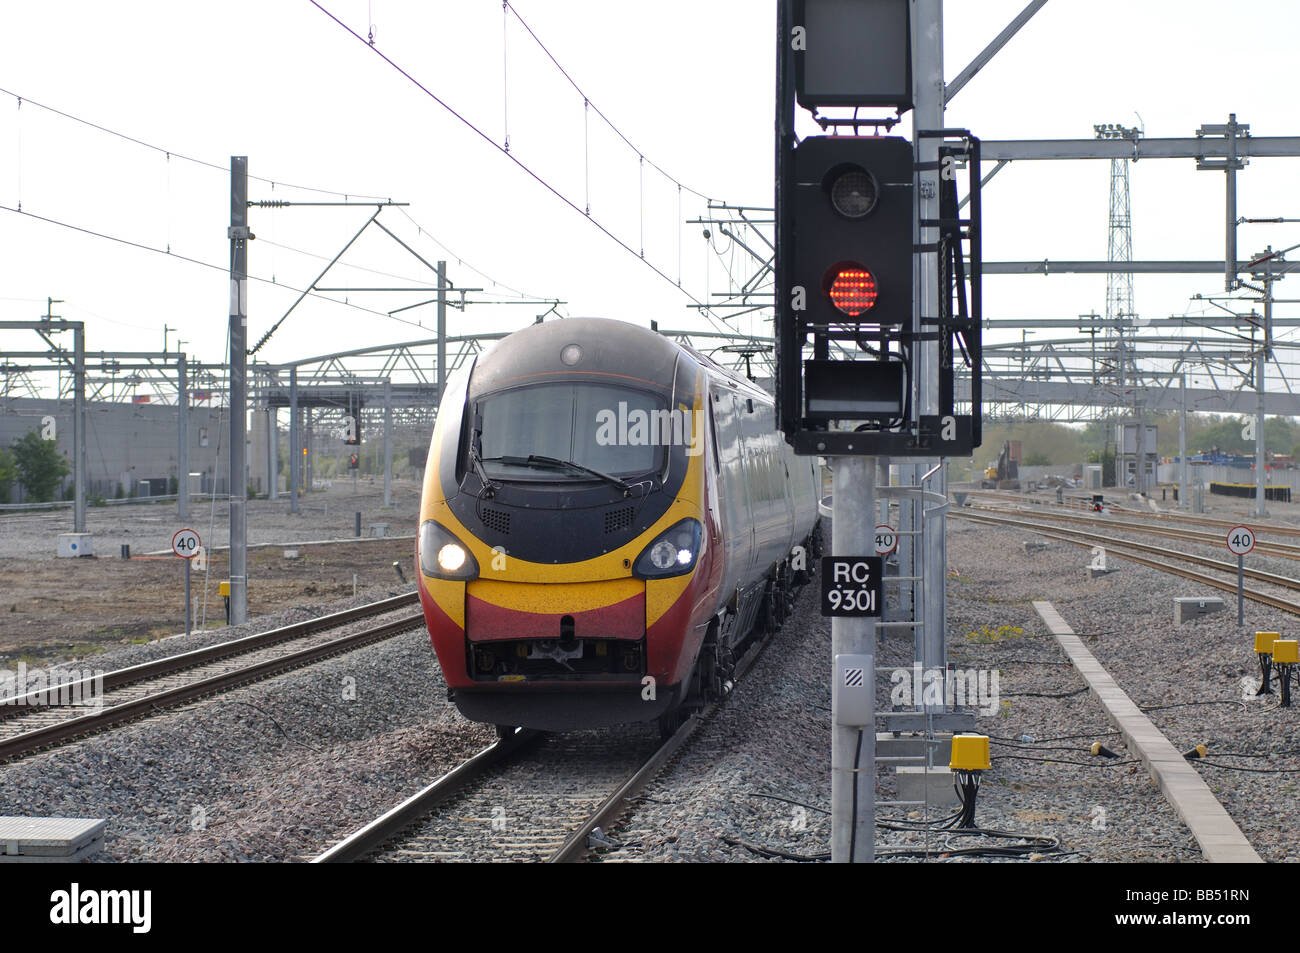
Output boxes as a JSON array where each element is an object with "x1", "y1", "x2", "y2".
[{"x1": 0, "y1": 593, "x2": 493, "y2": 861}]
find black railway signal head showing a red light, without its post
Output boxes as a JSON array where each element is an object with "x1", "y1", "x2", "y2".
[{"x1": 774, "y1": 0, "x2": 980, "y2": 456}]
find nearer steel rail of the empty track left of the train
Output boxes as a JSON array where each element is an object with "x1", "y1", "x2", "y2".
[{"x1": 0, "y1": 614, "x2": 424, "y2": 762}]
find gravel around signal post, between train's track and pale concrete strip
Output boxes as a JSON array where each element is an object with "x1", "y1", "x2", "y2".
[{"x1": 606, "y1": 520, "x2": 1201, "y2": 863}]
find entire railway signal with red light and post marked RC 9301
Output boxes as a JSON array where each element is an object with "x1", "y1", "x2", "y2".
[{"x1": 775, "y1": 0, "x2": 980, "y2": 862}]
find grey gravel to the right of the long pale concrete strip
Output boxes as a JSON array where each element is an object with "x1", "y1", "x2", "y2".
[{"x1": 985, "y1": 503, "x2": 1300, "y2": 861}]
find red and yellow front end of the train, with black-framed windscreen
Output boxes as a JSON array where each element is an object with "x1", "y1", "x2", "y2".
[{"x1": 417, "y1": 321, "x2": 720, "y2": 729}]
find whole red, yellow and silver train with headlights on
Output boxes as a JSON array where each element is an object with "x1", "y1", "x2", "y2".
[{"x1": 416, "y1": 319, "x2": 823, "y2": 736}]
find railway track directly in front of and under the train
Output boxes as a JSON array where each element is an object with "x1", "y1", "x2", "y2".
[{"x1": 312, "y1": 608, "x2": 770, "y2": 863}]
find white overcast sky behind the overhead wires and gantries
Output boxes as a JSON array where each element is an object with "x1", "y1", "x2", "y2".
[{"x1": 0, "y1": 0, "x2": 1300, "y2": 390}]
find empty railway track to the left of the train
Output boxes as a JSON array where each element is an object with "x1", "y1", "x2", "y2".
[{"x1": 0, "y1": 593, "x2": 424, "y2": 762}]
